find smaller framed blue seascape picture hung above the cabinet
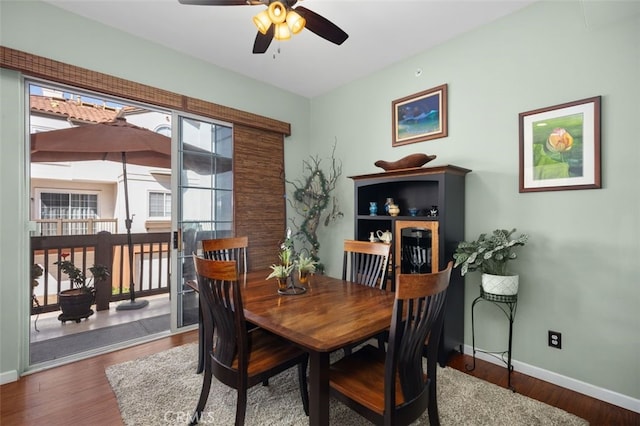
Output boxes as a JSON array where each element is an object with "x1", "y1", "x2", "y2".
[{"x1": 391, "y1": 84, "x2": 448, "y2": 146}]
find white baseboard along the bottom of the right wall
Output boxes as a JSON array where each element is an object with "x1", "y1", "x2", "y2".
[{"x1": 464, "y1": 345, "x2": 640, "y2": 413}]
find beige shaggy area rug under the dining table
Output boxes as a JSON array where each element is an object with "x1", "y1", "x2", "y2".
[{"x1": 106, "y1": 344, "x2": 588, "y2": 426}]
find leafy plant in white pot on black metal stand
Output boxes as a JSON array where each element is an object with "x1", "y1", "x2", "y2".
[{"x1": 453, "y1": 228, "x2": 529, "y2": 295}]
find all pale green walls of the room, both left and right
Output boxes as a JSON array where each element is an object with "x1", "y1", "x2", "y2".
[{"x1": 0, "y1": 1, "x2": 640, "y2": 410}]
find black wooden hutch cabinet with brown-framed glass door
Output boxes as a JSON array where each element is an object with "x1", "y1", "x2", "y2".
[{"x1": 350, "y1": 165, "x2": 470, "y2": 366}]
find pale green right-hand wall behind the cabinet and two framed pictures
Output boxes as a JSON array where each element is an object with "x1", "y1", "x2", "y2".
[{"x1": 311, "y1": 2, "x2": 640, "y2": 410}]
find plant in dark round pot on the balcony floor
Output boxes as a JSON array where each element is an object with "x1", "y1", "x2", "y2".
[{"x1": 55, "y1": 254, "x2": 109, "y2": 323}]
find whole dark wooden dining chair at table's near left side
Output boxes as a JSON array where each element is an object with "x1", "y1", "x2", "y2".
[{"x1": 191, "y1": 254, "x2": 309, "y2": 426}]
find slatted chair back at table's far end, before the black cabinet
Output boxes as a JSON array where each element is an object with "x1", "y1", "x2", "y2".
[{"x1": 342, "y1": 240, "x2": 391, "y2": 289}]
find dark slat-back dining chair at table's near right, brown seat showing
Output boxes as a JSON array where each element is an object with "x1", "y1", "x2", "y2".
[{"x1": 329, "y1": 262, "x2": 453, "y2": 426}]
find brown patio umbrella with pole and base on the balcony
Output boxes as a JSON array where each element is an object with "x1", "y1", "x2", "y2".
[{"x1": 31, "y1": 117, "x2": 231, "y2": 309}]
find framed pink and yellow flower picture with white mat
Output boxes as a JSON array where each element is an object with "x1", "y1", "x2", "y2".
[{"x1": 519, "y1": 96, "x2": 601, "y2": 192}]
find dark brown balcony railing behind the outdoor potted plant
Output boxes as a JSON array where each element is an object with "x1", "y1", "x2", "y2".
[{"x1": 31, "y1": 232, "x2": 171, "y2": 314}]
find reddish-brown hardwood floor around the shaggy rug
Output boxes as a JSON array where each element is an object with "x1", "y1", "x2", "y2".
[{"x1": 0, "y1": 331, "x2": 640, "y2": 426}]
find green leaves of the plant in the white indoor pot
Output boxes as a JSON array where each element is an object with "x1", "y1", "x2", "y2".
[{"x1": 453, "y1": 228, "x2": 529, "y2": 276}]
